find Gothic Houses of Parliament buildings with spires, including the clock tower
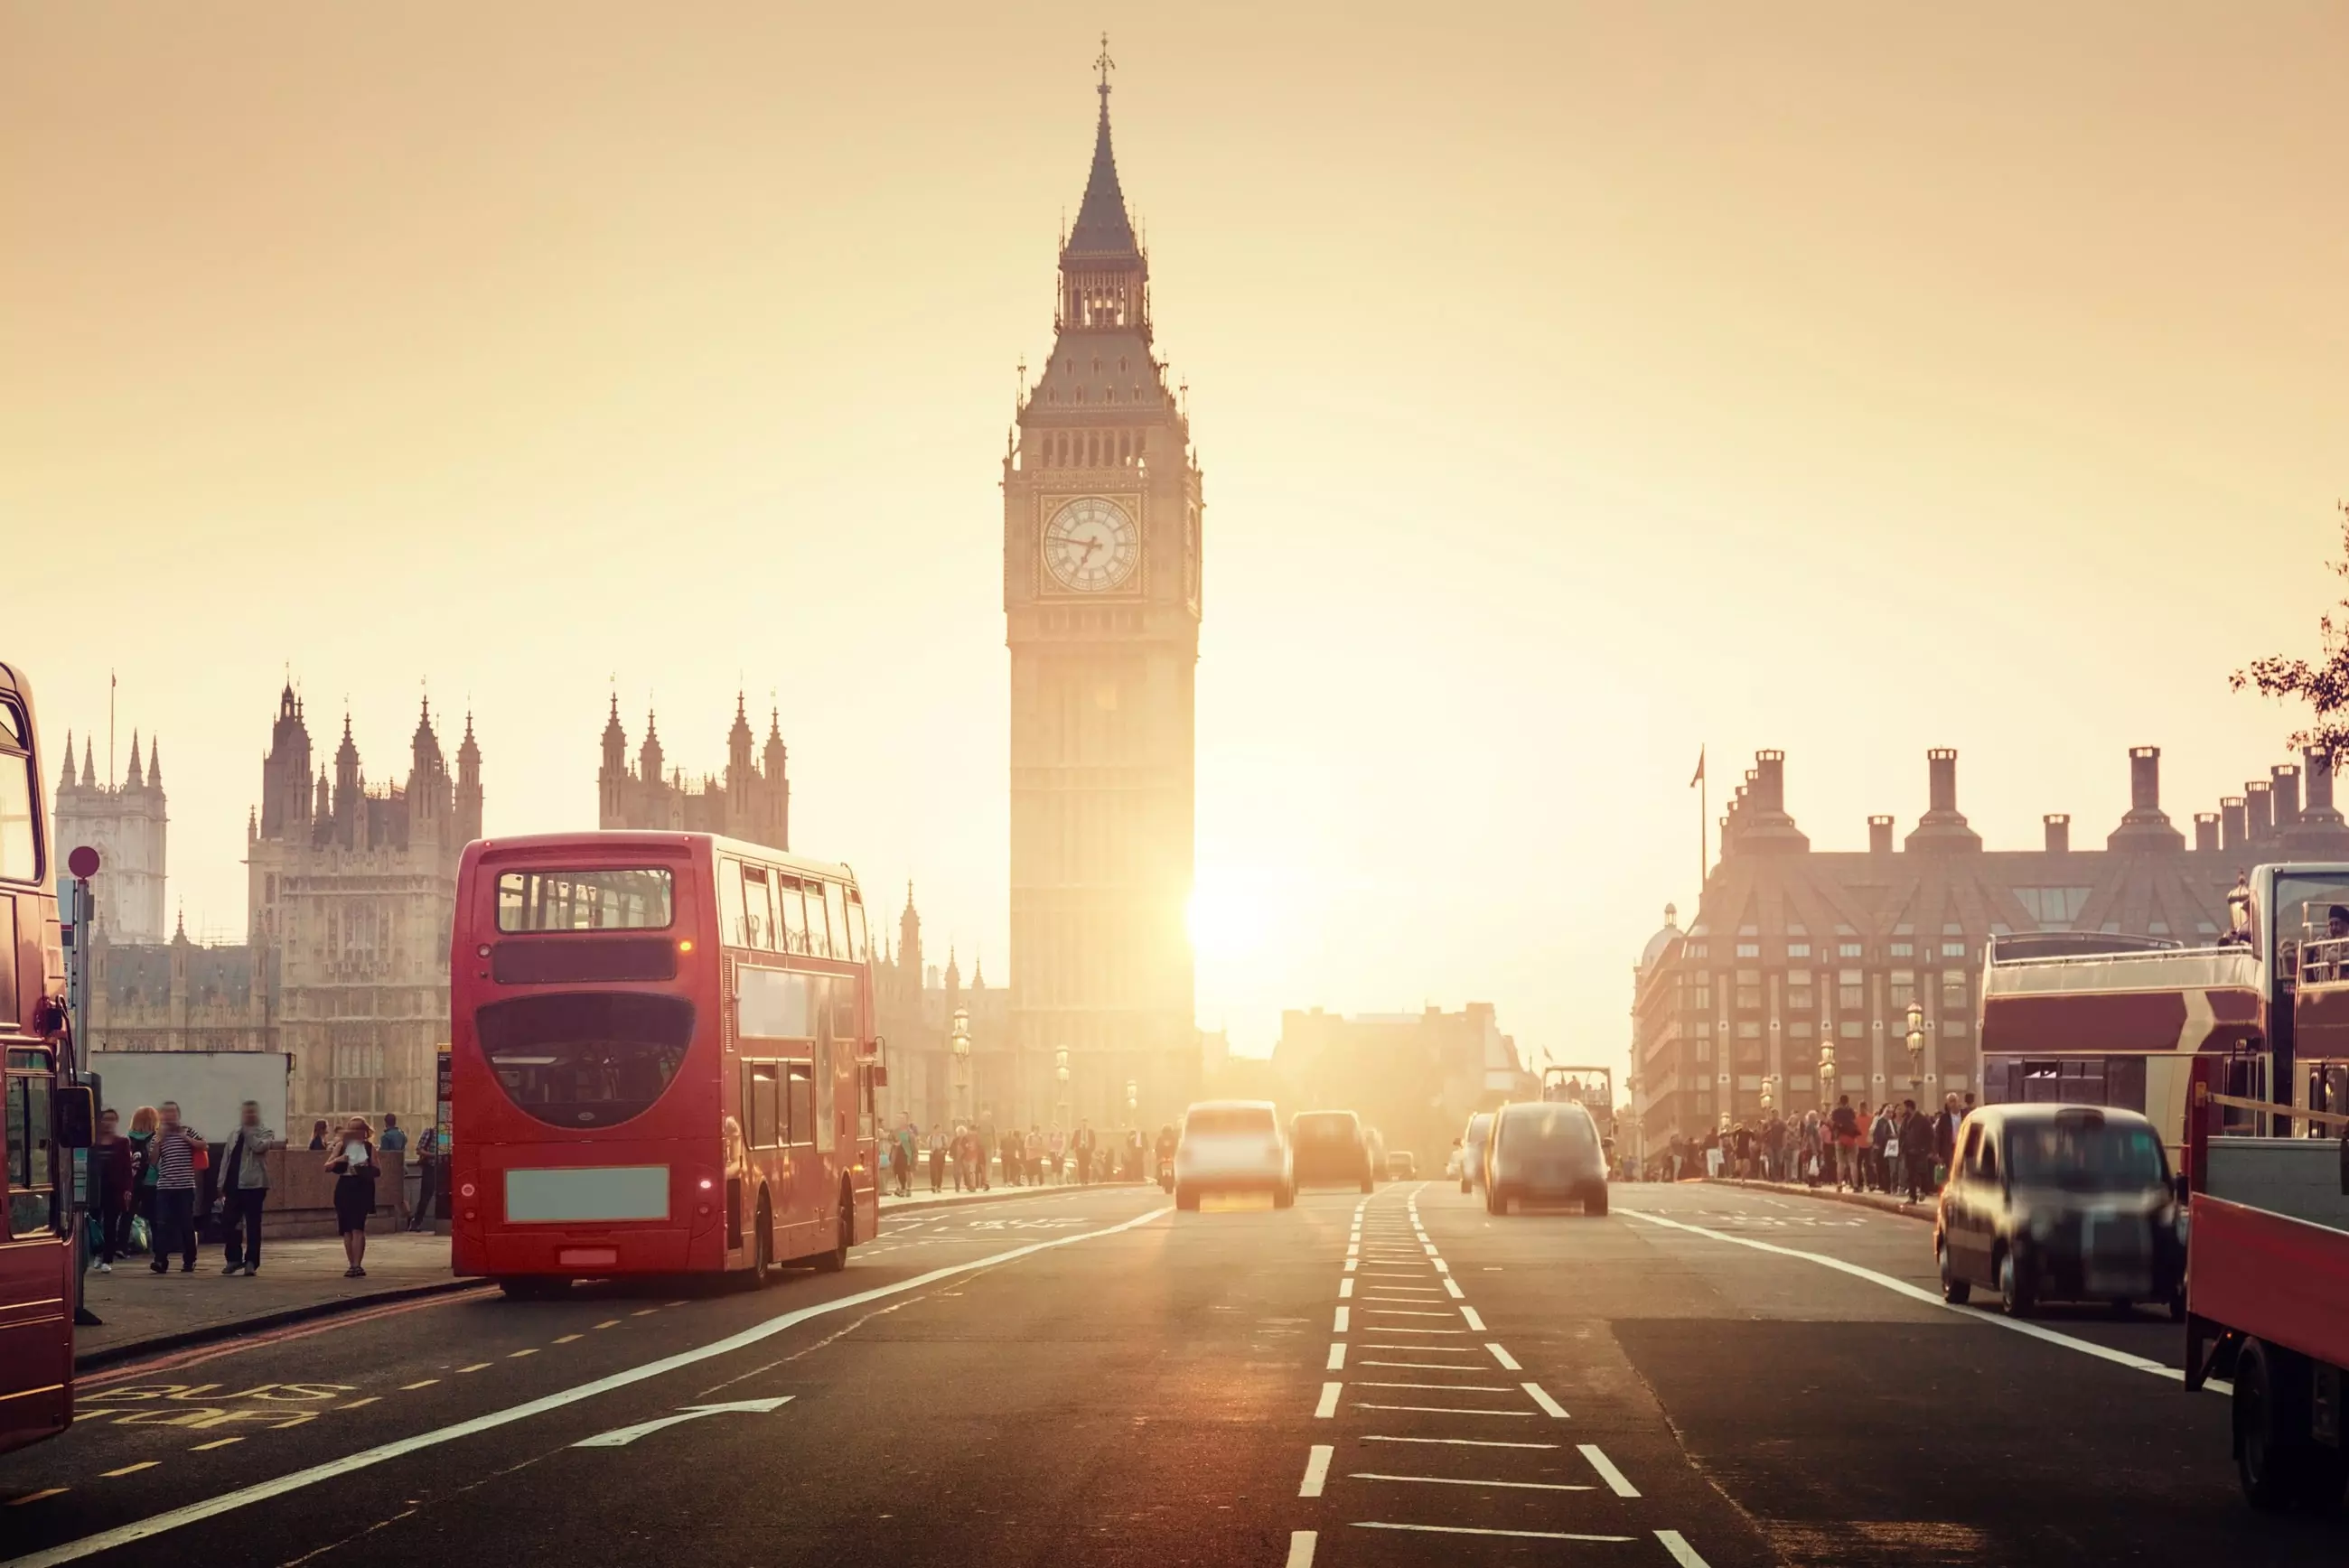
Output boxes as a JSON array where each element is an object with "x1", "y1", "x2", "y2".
[{"x1": 56, "y1": 64, "x2": 1205, "y2": 1129}]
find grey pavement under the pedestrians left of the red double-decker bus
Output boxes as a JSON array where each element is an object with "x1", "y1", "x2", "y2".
[{"x1": 73, "y1": 1232, "x2": 467, "y2": 1368}]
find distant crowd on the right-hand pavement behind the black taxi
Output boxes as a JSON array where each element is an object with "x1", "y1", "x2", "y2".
[{"x1": 1647, "y1": 1094, "x2": 1973, "y2": 1202}]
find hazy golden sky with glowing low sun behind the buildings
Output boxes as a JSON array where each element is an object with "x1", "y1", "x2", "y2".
[{"x1": 0, "y1": 0, "x2": 2349, "y2": 1054}]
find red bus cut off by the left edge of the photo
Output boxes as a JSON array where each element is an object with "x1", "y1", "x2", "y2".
[{"x1": 0, "y1": 664, "x2": 91, "y2": 1453}]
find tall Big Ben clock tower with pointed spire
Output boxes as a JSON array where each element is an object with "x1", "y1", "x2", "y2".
[{"x1": 998, "y1": 40, "x2": 1201, "y2": 1126}]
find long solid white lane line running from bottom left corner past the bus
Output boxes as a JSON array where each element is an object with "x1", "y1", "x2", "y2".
[{"x1": 0, "y1": 1209, "x2": 1172, "y2": 1568}]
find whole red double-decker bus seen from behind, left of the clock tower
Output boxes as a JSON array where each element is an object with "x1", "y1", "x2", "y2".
[{"x1": 449, "y1": 831, "x2": 885, "y2": 1296}]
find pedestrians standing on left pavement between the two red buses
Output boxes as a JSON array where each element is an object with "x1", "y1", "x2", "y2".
[{"x1": 89, "y1": 1101, "x2": 437, "y2": 1279}]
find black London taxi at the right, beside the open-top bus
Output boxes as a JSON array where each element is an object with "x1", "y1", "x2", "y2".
[{"x1": 1933, "y1": 1106, "x2": 2187, "y2": 1317}]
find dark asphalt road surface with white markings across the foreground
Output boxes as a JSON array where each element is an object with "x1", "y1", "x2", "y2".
[{"x1": 0, "y1": 1183, "x2": 2349, "y2": 1568}]
